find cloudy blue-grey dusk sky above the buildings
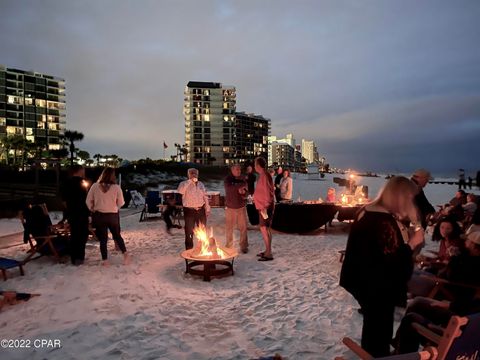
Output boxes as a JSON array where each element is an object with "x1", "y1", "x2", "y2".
[{"x1": 0, "y1": 0, "x2": 480, "y2": 174}]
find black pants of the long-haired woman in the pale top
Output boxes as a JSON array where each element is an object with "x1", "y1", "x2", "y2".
[{"x1": 92, "y1": 212, "x2": 127, "y2": 260}]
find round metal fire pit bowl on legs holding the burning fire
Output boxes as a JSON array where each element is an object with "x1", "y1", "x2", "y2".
[{"x1": 181, "y1": 246, "x2": 238, "y2": 281}]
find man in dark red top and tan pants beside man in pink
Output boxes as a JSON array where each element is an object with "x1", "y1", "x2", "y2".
[{"x1": 223, "y1": 164, "x2": 248, "y2": 254}]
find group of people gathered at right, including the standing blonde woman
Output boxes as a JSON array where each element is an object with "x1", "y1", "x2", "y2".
[{"x1": 340, "y1": 169, "x2": 480, "y2": 357}]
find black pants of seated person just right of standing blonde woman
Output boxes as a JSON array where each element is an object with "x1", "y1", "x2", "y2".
[{"x1": 395, "y1": 297, "x2": 454, "y2": 354}]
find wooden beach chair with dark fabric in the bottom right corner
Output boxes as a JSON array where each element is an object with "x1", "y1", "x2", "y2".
[{"x1": 336, "y1": 313, "x2": 480, "y2": 360}]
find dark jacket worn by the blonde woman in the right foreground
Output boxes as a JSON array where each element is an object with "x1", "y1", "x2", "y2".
[{"x1": 340, "y1": 209, "x2": 413, "y2": 306}]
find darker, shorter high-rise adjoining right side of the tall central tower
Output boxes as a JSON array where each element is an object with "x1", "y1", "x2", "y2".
[{"x1": 235, "y1": 112, "x2": 270, "y2": 163}]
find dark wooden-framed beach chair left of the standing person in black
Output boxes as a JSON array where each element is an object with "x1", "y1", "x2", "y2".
[{"x1": 22, "y1": 204, "x2": 68, "y2": 264}]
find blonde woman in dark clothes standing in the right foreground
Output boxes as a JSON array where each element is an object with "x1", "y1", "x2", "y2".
[{"x1": 340, "y1": 176, "x2": 424, "y2": 357}]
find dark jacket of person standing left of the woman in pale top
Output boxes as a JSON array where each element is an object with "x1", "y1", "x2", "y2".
[{"x1": 62, "y1": 176, "x2": 90, "y2": 219}]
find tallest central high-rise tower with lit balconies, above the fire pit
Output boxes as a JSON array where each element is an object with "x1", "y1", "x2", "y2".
[{"x1": 183, "y1": 81, "x2": 236, "y2": 165}]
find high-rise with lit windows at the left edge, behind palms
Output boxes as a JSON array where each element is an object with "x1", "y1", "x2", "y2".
[{"x1": 0, "y1": 65, "x2": 65, "y2": 150}]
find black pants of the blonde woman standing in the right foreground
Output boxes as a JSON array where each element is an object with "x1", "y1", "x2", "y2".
[{"x1": 360, "y1": 299, "x2": 395, "y2": 357}]
